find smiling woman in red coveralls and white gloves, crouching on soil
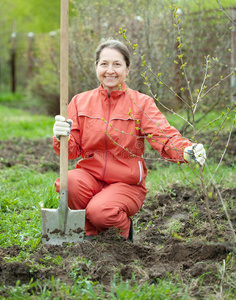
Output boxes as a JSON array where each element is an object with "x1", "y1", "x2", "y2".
[{"x1": 53, "y1": 40, "x2": 205, "y2": 241}]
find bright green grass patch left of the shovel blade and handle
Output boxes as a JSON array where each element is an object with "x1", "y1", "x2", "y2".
[{"x1": 0, "y1": 167, "x2": 58, "y2": 251}]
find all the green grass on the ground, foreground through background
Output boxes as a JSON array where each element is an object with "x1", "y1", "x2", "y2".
[{"x1": 0, "y1": 97, "x2": 235, "y2": 300}]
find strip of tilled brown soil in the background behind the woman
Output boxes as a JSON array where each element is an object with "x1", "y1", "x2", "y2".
[{"x1": 0, "y1": 131, "x2": 236, "y2": 172}]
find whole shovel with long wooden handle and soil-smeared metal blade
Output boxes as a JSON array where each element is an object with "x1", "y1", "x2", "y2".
[{"x1": 41, "y1": 0, "x2": 85, "y2": 245}]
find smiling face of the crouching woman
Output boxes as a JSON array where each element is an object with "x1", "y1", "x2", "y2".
[{"x1": 96, "y1": 48, "x2": 130, "y2": 93}]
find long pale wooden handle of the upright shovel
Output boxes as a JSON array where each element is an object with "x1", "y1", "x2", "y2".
[{"x1": 60, "y1": 0, "x2": 69, "y2": 191}]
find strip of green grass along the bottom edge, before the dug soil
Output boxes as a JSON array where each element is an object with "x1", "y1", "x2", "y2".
[{"x1": 0, "y1": 276, "x2": 187, "y2": 300}]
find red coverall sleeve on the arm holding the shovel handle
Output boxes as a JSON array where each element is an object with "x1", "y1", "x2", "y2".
[{"x1": 53, "y1": 96, "x2": 81, "y2": 159}]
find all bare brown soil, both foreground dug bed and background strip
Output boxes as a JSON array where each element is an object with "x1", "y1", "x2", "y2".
[{"x1": 0, "y1": 132, "x2": 236, "y2": 298}]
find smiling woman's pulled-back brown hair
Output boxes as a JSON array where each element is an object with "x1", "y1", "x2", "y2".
[{"x1": 95, "y1": 38, "x2": 130, "y2": 68}]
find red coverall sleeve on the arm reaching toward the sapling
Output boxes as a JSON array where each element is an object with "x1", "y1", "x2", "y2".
[{"x1": 141, "y1": 97, "x2": 192, "y2": 163}]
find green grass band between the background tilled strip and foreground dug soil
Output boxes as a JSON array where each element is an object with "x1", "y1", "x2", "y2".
[{"x1": 0, "y1": 159, "x2": 235, "y2": 251}]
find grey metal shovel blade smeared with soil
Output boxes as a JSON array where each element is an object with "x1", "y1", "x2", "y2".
[{"x1": 41, "y1": 208, "x2": 85, "y2": 245}]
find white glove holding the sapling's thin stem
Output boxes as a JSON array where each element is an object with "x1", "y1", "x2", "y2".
[{"x1": 184, "y1": 144, "x2": 206, "y2": 166}]
